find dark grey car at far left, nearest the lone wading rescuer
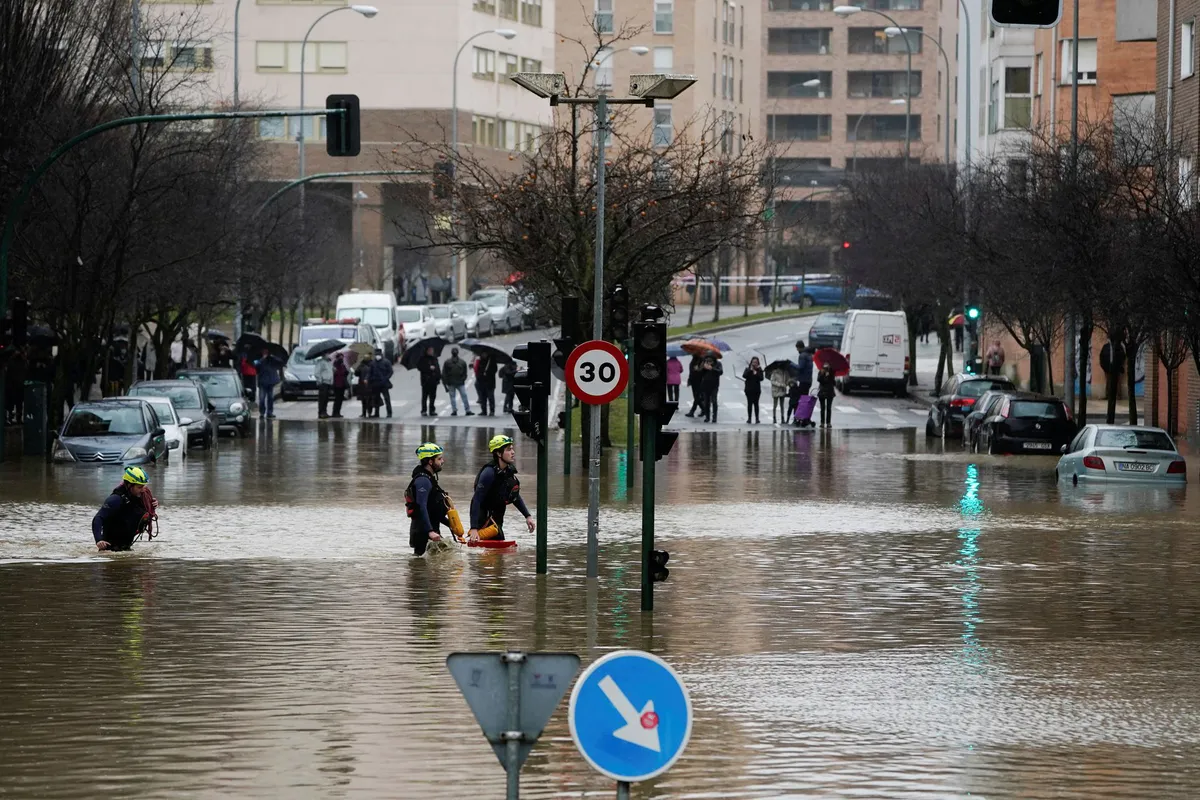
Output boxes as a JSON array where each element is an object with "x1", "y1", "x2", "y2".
[{"x1": 50, "y1": 397, "x2": 170, "y2": 464}]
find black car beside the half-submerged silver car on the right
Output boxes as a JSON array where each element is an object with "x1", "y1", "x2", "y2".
[{"x1": 977, "y1": 392, "x2": 1076, "y2": 456}]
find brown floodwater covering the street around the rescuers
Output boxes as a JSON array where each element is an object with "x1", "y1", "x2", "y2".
[{"x1": 0, "y1": 422, "x2": 1200, "y2": 800}]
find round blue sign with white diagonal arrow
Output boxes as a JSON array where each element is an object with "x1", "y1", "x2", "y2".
[{"x1": 569, "y1": 650, "x2": 691, "y2": 782}]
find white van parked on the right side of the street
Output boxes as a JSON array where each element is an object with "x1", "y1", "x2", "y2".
[{"x1": 839, "y1": 309, "x2": 911, "y2": 397}]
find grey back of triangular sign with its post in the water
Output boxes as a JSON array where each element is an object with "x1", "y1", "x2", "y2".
[{"x1": 446, "y1": 650, "x2": 580, "y2": 800}]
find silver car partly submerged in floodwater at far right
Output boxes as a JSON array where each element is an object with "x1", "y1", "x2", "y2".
[{"x1": 1055, "y1": 425, "x2": 1188, "y2": 486}]
